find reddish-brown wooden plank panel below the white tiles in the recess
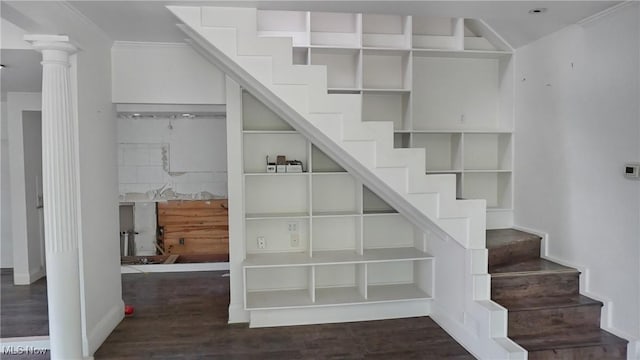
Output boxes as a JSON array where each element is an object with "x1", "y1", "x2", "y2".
[{"x1": 158, "y1": 199, "x2": 229, "y2": 257}]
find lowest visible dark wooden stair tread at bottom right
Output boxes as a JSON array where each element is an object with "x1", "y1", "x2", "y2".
[{"x1": 511, "y1": 330, "x2": 627, "y2": 351}]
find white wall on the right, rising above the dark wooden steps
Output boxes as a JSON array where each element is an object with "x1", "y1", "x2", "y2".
[{"x1": 515, "y1": 3, "x2": 640, "y2": 352}]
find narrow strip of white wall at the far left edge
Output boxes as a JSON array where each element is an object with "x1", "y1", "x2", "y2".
[{"x1": 0, "y1": 101, "x2": 13, "y2": 268}]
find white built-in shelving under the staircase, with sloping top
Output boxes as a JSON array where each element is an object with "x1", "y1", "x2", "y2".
[{"x1": 242, "y1": 92, "x2": 433, "y2": 310}]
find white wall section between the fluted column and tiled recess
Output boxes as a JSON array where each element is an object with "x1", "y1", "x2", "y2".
[{"x1": 72, "y1": 42, "x2": 124, "y2": 355}]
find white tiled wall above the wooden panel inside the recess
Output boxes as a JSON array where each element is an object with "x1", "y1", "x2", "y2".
[{"x1": 117, "y1": 117, "x2": 227, "y2": 201}]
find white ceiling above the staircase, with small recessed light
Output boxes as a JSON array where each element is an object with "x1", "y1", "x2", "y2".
[{"x1": 71, "y1": 0, "x2": 619, "y2": 48}]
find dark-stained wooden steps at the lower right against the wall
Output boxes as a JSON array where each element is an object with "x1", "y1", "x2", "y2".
[{"x1": 487, "y1": 229, "x2": 627, "y2": 360}]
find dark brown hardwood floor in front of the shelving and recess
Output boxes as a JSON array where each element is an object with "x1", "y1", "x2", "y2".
[{"x1": 2, "y1": 271, "x2": 474, "y2": 360}]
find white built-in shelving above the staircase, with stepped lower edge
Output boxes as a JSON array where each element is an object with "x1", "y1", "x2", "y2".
[{"x1": 258, "y1": 11, "x2": 514, "y2": 227}]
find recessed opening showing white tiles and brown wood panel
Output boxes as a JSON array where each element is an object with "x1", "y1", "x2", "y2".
[{"x1": 117, "y1": 104, "x2": 229, "y2": 272}]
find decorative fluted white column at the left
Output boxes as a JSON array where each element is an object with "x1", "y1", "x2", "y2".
[{"x1": 25, "y1": 35, "x2": 82, "y2": 360}]
